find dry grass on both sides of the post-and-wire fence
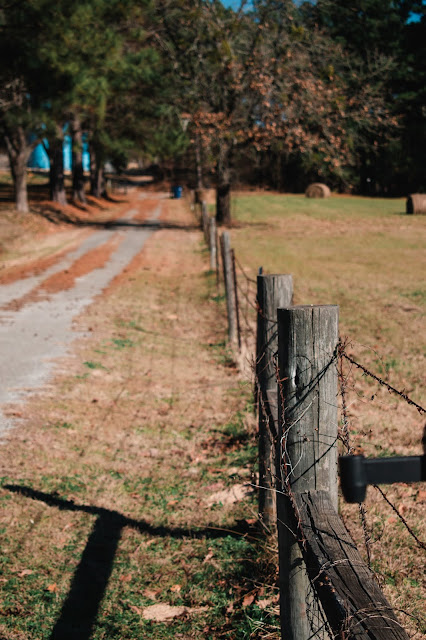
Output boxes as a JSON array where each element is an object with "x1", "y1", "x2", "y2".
[{"x1": 0, "y1": 194, "x2": 426, "y2": 640}]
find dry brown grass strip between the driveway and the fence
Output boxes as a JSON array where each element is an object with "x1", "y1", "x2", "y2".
[{"x1": 0, "y1": 192, "x2": 276, "y2": 640}]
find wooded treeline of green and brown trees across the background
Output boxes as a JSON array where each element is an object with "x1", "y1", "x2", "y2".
[{"x1": 0, "y1": 0, "x2": 426, "y2": 222}]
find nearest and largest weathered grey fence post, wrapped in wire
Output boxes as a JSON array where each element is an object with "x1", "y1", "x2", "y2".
[{"x1": 277, "y1": 305, "x2": 338, "y2": 640}]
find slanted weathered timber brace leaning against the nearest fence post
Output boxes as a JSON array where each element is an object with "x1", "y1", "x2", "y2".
[{"x1": 295, "y1": 491, "x2": 408, "y2": 640}]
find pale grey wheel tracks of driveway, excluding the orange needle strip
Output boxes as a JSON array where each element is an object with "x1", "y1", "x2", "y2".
[{"x1": 0, "y1": 194, "x2": 162, "y2": 435}]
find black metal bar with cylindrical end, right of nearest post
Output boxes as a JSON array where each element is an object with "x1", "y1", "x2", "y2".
[{"x1": 339, "y1": 455, "x2": 426, "y2": 502}]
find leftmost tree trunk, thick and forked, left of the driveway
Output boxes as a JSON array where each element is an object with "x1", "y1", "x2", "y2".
[{"x1": 5, "y1": 127, "x2": 34, "y2": 213}]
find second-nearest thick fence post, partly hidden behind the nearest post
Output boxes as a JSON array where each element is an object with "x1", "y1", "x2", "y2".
[{"x1": 256, "y1": 275, "x2": 293, "y2": 528}]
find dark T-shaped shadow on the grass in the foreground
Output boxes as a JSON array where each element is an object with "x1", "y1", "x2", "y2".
[{"x1": 3, "y1": 485, "x2": 258, "y2": 640}]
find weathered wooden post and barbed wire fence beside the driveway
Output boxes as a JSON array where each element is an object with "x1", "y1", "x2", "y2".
[{"x1": 198, "y1": 200, "x2": 425, "y2": 640}]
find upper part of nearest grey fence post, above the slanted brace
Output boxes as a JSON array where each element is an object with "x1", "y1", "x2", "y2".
[{"x1": 278, "y1": 305, "x2": 339, "y2": 510}]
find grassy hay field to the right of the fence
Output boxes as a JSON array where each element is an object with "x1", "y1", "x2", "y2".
[{"x1": 226, "y1": 193, "x2": 426, "y2": 638}]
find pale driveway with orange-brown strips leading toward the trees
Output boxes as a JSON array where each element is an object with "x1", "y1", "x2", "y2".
[{"x1": 0, "y1": 191, "x2": 168, "y2": 434}]
